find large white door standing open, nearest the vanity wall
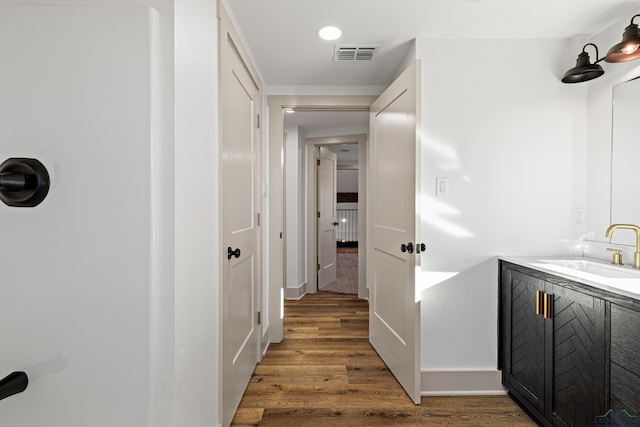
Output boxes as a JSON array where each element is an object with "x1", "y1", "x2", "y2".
[{"x1": 368, "y1": 62, "x2": 420, "y2": 404}]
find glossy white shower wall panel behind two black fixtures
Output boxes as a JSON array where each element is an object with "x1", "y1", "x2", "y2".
[{"x1": 0, "y1": 1, "x2": 168, "y2": 427}]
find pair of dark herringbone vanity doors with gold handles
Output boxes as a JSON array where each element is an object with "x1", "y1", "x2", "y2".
[{"x1": 500, "y1": 261, "x2": 609, "y2": 426}]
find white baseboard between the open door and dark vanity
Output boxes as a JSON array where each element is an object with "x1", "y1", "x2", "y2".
[{"x1": 420, "y1": 369, "x2": 507, "y2": 396}]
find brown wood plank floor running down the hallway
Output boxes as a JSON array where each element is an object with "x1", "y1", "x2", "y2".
[{"x1": 232, "y1": 292, "x2": 536, "y2": 427}]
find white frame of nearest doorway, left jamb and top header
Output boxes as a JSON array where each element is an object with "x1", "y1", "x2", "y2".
[{"x1": 268, "y1": 95, "x2": 378, "y2": 342}]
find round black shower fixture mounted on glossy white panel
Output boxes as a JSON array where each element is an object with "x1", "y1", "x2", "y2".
[{"x1": 0, "y1": 158, "x2": 49, "y2": 208}]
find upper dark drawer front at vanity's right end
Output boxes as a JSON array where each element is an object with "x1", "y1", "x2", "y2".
[{"x1": 611, "y1": 304, "x2": 640, "y2": 376}]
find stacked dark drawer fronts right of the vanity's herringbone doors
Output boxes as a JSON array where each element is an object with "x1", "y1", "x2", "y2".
[{"x1": 610, "y1": 304, "x2": 640, "y2": 416}]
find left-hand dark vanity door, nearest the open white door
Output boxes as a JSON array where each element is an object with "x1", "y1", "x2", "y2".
[{"x1": 502, "y1": 269, "x2": 545, "y2": 413}]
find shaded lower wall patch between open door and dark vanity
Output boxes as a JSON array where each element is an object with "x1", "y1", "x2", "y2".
[{"x1": 417, "y1": 257, "x2": 498, "y2": 369}]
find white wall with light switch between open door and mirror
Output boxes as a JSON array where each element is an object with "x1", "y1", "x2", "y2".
[{"x1": 416, "y1": 39, "x2": 587, "y2": 369}]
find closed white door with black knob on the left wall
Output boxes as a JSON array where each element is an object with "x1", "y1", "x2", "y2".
[{"x1": 220, "y1": 11, "x2": 260, "y2": 425}]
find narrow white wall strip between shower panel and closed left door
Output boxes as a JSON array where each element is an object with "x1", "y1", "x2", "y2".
[{"x1": 173, "y1": 0, "x2": 220, "y2": 427}]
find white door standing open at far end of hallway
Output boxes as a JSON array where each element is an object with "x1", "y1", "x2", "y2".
[{"x1": 317, "y1": 147, "x2": 338, "y2": 290}]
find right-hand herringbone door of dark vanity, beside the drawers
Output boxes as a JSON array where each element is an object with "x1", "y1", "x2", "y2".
[{"x1": 545, "y1": 285, "x2": 608, "y2": 426}]
